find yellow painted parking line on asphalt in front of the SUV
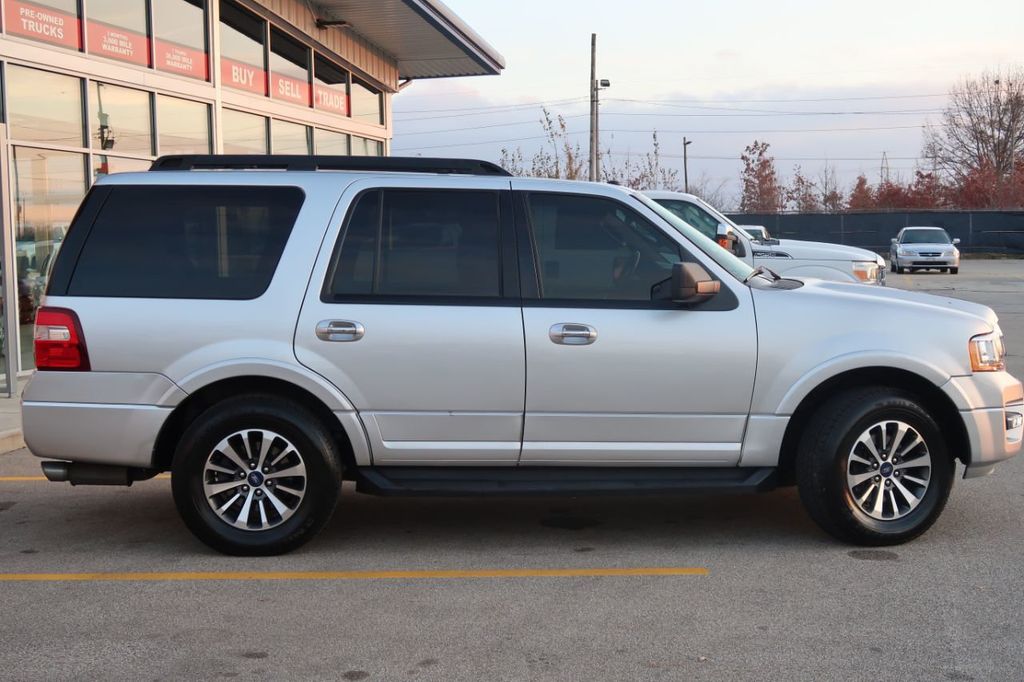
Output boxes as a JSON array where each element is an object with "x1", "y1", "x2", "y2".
[{"x1": 0, "y1": 566, "x2": 708, "y2": 583}]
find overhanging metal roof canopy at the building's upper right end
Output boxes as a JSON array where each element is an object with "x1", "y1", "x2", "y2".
[{"x1": 310, "y1": 0, "x2": 505, "y2": 79}]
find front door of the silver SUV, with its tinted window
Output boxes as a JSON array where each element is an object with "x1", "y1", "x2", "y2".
[{"x1": 513, "y1": 180, "x2": 757, "y2": 466}]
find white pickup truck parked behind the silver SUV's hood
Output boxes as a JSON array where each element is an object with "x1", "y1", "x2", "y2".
[{"x1": 644, "y1": 190, "x2": 886, "y2": 286}]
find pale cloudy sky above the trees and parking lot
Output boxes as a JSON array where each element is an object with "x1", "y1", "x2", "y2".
[{"x1": 392, "y1": 0, "x2": 1024, "y2": 205}]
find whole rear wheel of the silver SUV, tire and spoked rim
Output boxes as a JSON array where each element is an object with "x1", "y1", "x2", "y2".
[{"x1": 171, "y1": 395, "x2": 341, "y2": 556}]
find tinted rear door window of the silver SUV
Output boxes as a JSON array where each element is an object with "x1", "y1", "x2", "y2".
[{"x1": 328, "y1": 189, "x2": 501, "y2": 297}]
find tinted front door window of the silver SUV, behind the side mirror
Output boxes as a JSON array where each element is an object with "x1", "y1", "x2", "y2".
[{"x1": 529, "y1": 194, "x2": 683, "y2": 301}]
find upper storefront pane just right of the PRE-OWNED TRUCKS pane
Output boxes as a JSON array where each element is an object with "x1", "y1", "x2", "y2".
[{"x1": 85, "y1": 0, "x2": 150, "y2": 67}]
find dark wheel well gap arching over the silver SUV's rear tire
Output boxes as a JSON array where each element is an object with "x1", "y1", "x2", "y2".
[{"x1": 153, "y1": 377, "x2": 355, "y2": 471}]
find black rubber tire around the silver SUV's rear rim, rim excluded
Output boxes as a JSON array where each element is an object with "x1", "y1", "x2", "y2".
[{"x1": 171, "y1": 394, "x2": 342, "y2": 556}]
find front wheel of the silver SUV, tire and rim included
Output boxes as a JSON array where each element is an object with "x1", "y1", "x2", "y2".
[{"x1": 797, "y1": 388, "x2": 954, "y2": 546}]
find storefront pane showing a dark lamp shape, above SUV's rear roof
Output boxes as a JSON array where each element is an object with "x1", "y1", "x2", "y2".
[{"x1": 89, "y1": 81, "x2": 153, "y2": 156}]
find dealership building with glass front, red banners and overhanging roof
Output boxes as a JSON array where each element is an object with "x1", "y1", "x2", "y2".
[{"x1": 0, "y1": 0, "x2": 504, "y2": 378}]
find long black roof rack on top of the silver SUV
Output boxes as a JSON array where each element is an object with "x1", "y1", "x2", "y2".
[{"x1": 150, "y1": 154, "x2": 511, "y2": 177}]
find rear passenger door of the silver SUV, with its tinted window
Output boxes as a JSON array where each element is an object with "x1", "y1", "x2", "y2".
[{"x1": 295, "y1": 177, "x2": 525, "y2": 466}]
